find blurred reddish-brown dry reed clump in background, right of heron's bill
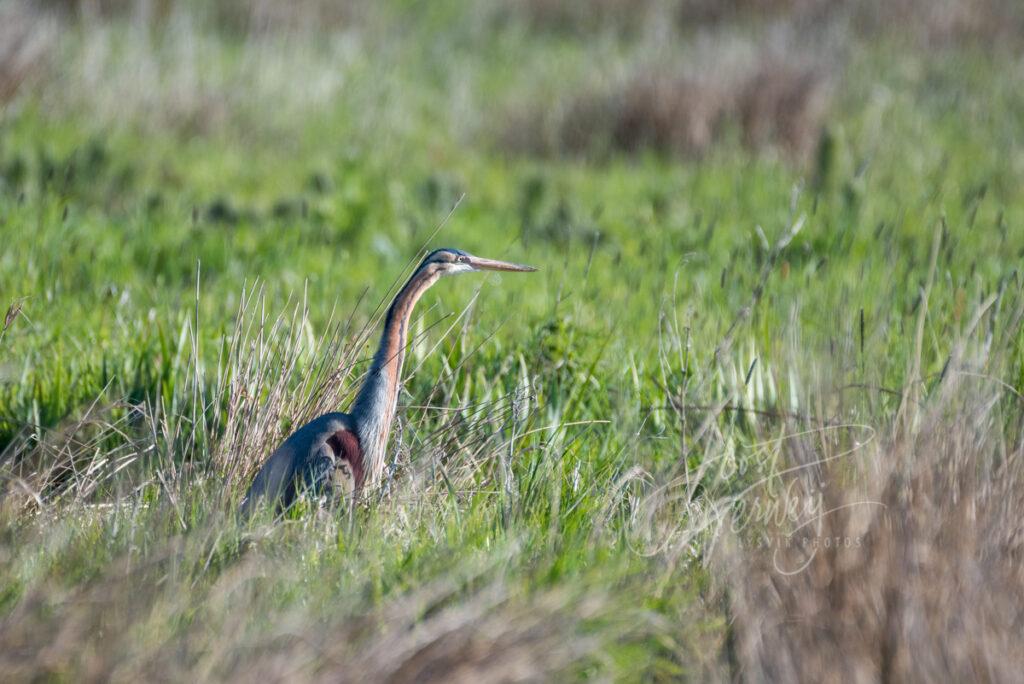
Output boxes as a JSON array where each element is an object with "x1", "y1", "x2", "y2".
[{"x1": 503, "y1": 56, "x2": 829, "y2": 161}]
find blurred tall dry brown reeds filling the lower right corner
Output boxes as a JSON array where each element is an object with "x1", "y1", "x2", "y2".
[{"x1": 724, "y1": 385, "x2": 1024, "y2": 682}]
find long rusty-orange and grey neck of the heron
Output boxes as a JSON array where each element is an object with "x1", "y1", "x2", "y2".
[{"x1": 351, "y1": 265, "x2": 439, "y2": 484}]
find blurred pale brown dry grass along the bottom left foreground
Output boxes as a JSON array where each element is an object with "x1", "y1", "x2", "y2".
[{"x1": 0, "y1": 552, "x2": 632, "y2": 682}]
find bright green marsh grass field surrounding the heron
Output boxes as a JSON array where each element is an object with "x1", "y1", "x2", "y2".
[{"x1": 0, "y1": 3, "x2": 1024, "y2": 680}]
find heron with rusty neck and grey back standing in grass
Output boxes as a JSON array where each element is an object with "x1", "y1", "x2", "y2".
[{"x1": 242, "y1": 248, "x2": 537, "y2": 514}]
